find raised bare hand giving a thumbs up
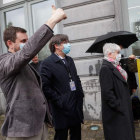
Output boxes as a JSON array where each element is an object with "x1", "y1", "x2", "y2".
[{"x1": 46, "y1": 5, "x2": 67, "y2": 29}]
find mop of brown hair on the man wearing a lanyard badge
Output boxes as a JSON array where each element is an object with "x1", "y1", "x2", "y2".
[{"x1": 49, "y1": 34, "x2": 69, "y2": 53}]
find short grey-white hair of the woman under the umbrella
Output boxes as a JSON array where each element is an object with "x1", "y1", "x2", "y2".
[{"x1": 103, "y1": 43, "x2": 121, "y2": 57}]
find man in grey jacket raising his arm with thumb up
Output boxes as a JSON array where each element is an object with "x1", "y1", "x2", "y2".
[{"x1": 0, "y1": 6, "x2": 67, "y2": 140}]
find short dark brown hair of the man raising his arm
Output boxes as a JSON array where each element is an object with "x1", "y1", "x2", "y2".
[{"x1": 3, "y1": 26, "x2": 27, "y2": 48}]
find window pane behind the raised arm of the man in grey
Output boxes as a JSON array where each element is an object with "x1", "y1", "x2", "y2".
[{"x1": 31, "y1": 0, "x2": 58, "y2": 60}]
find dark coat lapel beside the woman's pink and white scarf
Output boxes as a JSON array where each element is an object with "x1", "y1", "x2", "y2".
[{"x1": 103, "y1": 60, "x2": 127, "y2": 84}]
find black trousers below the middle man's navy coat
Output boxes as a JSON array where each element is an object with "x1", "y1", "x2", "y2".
[{"x1": 54, "y1": 123, "x2": 81, "y2": 140}]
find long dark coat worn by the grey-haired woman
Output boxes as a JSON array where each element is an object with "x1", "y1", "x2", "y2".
[{"x1": 100, "y1": 60, "x2": 135, "y2": 140}]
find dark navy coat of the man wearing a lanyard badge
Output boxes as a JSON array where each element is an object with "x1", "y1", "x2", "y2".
[{"x1": 40, "y1": 53, "x2": 84, "y2": 129}]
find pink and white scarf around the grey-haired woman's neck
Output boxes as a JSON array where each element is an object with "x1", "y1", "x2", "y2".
[{"x1": 104, "y1": 57, "x2": 128, "y2": 81}]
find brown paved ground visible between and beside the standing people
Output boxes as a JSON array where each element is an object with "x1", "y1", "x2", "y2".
[{"x1": 0, "y1": 116, "x2": 140, "y2": 140}]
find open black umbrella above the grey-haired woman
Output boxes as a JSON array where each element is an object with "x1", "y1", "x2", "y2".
[{"x1": 86, "y1": 31, "x2": 138, "y2": 53}]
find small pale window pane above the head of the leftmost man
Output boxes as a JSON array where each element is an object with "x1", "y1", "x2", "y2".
[{"x1": 5, "y1": 8, "x2": 25, "y2": 28}]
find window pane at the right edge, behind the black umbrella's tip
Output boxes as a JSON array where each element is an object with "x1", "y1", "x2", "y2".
[{"x1": 128, "y1": 0, "x2": 140, "y2": 56}]
